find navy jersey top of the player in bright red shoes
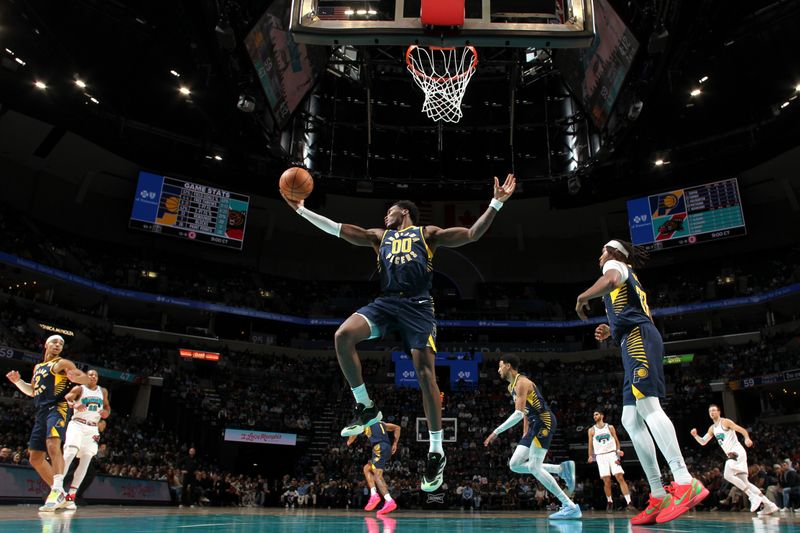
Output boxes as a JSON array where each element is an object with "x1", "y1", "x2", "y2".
[{"x1": 603, "y1": 261, "x2": 653, "y2": 342}]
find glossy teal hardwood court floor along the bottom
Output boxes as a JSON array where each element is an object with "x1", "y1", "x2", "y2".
[{"x1": 0, "y1": 505, "x2": 800, "y2": 533}]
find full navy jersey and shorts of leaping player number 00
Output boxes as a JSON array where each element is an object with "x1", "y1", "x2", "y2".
[{"x1": 356, "y1": 226, "x2": 436, "y2": 354}]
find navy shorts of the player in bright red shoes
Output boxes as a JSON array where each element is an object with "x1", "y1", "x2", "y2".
[{"x1": 620, "y1": 323, "x2": 666, "y2": 405}]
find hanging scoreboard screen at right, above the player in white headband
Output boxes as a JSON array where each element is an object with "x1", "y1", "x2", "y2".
[{"x1": 628, "y1": 178, "x2": 747, "y2": 251}]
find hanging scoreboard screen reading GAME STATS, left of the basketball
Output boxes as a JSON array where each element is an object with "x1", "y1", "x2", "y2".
[{"x1": 129, "y1": 172, "x2": 250, "y2": 250}]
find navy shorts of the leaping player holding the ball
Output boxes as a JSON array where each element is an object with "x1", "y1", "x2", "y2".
[{"x1": 356, "y1": 296, "x2": 436, "y2": 354}]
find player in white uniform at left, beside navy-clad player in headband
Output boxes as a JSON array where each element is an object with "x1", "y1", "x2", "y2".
[{"x1": 64, "y1": 370, "x2": 111, "y2": 509}]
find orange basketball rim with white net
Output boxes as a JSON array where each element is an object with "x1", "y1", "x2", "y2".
[{"x1": 406, "y1": 45, "x2": 478, "y2": 122}]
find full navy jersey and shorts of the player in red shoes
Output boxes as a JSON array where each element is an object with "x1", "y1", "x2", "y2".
[{"x1": 603, "y1": 260, "x2": 666, "y2": 405}]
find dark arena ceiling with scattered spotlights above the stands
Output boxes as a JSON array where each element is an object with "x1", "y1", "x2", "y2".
[{"x1": 0, "y1": 0, "x2": 800, "y2": 202}]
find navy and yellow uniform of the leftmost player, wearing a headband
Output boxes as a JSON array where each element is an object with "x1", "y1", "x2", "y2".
[{"x1": 28, "y1": 357, "x2": 69, "y2": 452}]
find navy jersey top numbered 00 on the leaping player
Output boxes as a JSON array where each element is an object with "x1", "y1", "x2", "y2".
[{"x1": 378, "y1": 226, "x2": 433, "y2": 296}]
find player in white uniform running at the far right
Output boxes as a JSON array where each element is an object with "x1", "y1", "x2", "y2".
[{"x1": 691, "y1": 403, "x2": 778, "y2": 515}]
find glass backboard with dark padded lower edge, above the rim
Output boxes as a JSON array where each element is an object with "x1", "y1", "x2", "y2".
[{"x1": 290, "y1": 0, "x2": 594, "y2": 48}]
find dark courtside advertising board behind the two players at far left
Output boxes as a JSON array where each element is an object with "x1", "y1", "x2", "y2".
[{"x1": 0, "y1": 465, "x2": 170, "y2": 503}]
